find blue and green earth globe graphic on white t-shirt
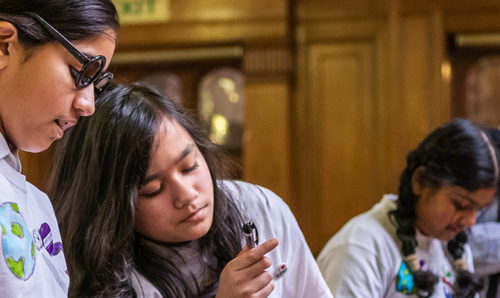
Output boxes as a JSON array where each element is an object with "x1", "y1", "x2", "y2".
[{"x1": 0, "y1": 202, "x2": 35, "y2": 280}]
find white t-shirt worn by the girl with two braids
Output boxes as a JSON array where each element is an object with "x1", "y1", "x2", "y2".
[{"x1": 318, "y1": 195, "x2": 473, "y2": 298}]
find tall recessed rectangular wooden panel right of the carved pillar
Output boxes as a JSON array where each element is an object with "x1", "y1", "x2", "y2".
[{"x1": 297, "y1": 41, "x2": 383, "y2": 253}]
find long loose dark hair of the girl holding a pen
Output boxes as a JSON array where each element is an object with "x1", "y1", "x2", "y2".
[{"x1": 50, "y1": 84, "x2": 242, "y2": 297}]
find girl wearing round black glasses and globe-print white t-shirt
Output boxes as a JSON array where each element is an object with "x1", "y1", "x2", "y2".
[{"x1": 0, "y1": 0, "x2": 119, "y2": 297}]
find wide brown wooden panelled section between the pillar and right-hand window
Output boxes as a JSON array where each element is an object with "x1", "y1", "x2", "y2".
[{"x1": 292, "y1": 0, "x2": 450, "y2": 253}]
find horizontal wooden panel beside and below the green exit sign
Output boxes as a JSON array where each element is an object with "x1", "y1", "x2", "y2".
[{"x1": 117, "y1": 0, "x2": 289, "y2": 52}]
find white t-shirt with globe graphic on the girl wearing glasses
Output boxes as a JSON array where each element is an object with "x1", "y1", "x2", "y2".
[{"x1": 0, "y1": 134, "x2": 69, "y2": 298}]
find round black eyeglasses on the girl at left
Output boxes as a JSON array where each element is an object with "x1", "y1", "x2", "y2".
[{"x1": 23, "y1": 12, "x2": 113, "y2": 98}]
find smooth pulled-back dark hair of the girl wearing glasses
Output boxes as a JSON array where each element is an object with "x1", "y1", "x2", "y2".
[{"x1": 0, "y1": 0, "x2": 120, "y2": 48}]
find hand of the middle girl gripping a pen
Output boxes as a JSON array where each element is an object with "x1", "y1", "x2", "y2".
[{"x1": 216, "y1": 239, "x2": 278, "y2": 298}]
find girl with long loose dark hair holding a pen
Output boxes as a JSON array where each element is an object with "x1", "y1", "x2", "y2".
[{"x1": 51, "y1": 85, "x2": 331, "y2": 298}]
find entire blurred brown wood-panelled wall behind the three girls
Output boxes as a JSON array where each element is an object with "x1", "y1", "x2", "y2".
[{"x1": 21, "y1": 0, "x2": 500, "y2": 255}]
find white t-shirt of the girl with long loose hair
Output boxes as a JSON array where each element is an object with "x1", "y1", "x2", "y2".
[{"x1": 132, "y1": 181, "x2": 332, "y2": 298}]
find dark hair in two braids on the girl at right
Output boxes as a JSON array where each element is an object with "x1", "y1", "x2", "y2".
[{"x1": 391, "y1": 119, "x2": 498, "y2": 297}]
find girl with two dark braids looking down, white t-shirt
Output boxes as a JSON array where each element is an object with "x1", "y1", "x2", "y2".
[{"x1": 318, "y1": 119, "x2": 499, "y2": 297}]
